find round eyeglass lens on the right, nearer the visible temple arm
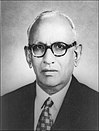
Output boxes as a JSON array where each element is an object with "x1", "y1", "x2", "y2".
[{"x1": 52, "y1": 42, "x2": 66, "y2": 55}]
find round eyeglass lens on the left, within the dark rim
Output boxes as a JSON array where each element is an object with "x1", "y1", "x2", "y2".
[{"x1": 32, "y1": 44, "x2": 45, "y2": 57}]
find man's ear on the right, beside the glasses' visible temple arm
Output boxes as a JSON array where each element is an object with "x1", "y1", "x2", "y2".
[{"x1": 74, "y1": 44, "x2": 82, "y2": 67}]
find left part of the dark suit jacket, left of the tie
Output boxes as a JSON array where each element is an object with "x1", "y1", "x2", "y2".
[{"x1": 1, "y1": 82, "x2": 36, "y2": 129}]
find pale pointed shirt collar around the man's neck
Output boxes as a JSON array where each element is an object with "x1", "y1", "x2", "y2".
[{"x1": 36, "y1": 79, "x2": 71, "y2": 111}]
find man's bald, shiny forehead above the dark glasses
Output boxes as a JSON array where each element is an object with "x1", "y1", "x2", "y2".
[{"x1": 31, "y1": 16, "x2": 74, "y2": 43}]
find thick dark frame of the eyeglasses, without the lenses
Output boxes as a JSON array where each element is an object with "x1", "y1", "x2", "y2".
[{"x1": 28, "y1": 41, "x2": 77, "y2": 58}]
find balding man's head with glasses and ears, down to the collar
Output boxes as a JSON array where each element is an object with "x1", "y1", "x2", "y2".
[{"x1": 25, "y1": 11, "x2": 81, "y2": 94}]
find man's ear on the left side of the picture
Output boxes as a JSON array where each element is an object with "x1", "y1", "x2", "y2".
[{"x1": 24, "y1": 46, "x2": 32, "y2": 68}]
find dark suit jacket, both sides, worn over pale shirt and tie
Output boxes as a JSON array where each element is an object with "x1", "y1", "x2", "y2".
[{"x1": 2, "y1": 76, "x2": 98, "y2": 131}]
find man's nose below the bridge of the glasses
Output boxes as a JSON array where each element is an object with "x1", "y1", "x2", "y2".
[{"x1": 43, "y1": 49, "x2": 55, "y2": 65}]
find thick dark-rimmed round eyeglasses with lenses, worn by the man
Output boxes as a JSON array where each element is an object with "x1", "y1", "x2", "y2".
[{"x1": 29, "y1": 41, "x2": 76, "y2": 58}]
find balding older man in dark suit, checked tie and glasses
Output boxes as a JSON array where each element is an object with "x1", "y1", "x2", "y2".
[{"x1": 2, "y1": 11, "x2": 98, "y2": 131}]
